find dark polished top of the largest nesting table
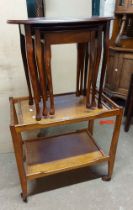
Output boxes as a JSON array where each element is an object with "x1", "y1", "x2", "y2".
[{"x1": 7, "y1": 16, "x2": 113, "y2": 26}]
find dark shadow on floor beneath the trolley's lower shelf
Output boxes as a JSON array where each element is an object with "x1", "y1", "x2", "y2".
[{"x1": 29, "y1": 167, "x2": 105, "y2": 195}]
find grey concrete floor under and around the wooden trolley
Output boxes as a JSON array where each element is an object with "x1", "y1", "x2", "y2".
[{"x1": 0, "y1": 117, "x2": 133, "y2": 210}]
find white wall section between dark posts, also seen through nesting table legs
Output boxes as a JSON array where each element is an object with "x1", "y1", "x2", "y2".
[{"x1": 46, "y1": 0, "x2": 91, "y2": 93}]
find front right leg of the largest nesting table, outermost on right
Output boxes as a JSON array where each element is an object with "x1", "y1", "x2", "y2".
[{"x1": 98, "y1": 22, "x2": 110, "y2": 108}]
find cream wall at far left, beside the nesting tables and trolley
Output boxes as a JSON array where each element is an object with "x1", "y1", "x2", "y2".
[{"x1": 0, "y1": 0, "x2": 27, "y2": 153}]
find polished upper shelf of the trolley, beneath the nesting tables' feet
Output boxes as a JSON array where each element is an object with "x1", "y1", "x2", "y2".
[{"x1": 13, "y1": 94, "x2": 119, "y2": 130}]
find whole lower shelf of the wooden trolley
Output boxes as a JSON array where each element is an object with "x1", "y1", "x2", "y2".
[{"x1": 25, "y1": 130, "x2": 109, "y2": 179}]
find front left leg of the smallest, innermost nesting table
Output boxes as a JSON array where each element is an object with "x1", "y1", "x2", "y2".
[{"x1": 44, "y1": 40, "x2": 55, "y2": 115}]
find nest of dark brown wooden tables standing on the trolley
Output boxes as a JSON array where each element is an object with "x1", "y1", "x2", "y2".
[{"x1": 8, "y1": 17, "x2": 112, "y2": 120}]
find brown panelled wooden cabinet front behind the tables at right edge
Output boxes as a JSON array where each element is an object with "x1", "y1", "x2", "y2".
[{"x1": 104, "y1": 50, "x2": 133, "y2": 100}]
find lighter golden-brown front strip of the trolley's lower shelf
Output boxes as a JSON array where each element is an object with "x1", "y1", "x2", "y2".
[{"x1": 26, "y1": 151, "x2": 109, "y2": 180}]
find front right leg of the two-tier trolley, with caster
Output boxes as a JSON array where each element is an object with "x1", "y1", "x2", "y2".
[{"x1": 102, "y1": 108, "x2": 123, "y2": 181}]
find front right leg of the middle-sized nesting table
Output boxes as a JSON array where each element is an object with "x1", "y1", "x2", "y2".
[{"x1": 91, "y1": 31, "x2": 102, "y2": 108}]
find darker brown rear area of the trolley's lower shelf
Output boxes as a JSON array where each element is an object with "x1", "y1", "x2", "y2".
[{"x1": 25, "y1": 131, "x2": 98, "y2": 165}]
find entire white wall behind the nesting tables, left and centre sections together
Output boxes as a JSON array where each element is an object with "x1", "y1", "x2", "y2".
[{"x1": 0, "y1": 0, "x2": 91, "y2": 153}]
